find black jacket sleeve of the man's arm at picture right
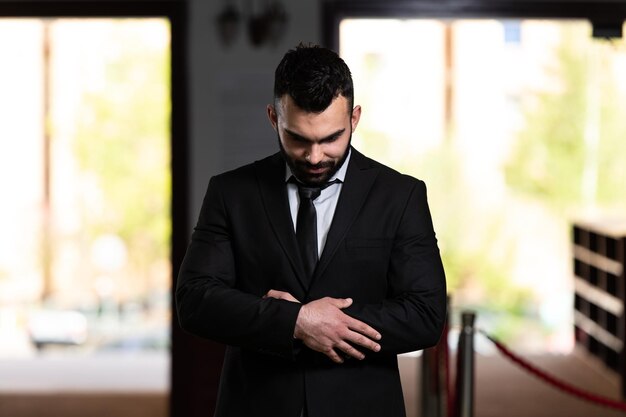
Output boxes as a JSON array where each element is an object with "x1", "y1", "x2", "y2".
[{"x1": 346, "y1": 181, "x2": 446, "y2": 354}]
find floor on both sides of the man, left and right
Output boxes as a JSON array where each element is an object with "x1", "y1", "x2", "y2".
[{"x1": 0, "y1": 352, "x2": 626, "y2": 417}]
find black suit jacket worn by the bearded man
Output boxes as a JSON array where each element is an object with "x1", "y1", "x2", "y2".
[{"x1": 176, "y1": 149, "x2": 446, "y2": 417}]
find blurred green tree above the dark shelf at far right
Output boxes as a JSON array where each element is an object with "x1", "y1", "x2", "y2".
[{"x1": 505, "y1": 25, "x2": 626, "y2": 211}]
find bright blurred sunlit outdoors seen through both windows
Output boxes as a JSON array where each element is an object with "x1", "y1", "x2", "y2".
[{"x1": 0, "y1": 19, "x2": 626, "y2": 394}]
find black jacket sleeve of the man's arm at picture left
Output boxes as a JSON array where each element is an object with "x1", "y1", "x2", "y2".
[{"x1": 176, "y1": 176, "x2": 300, "y2": 358}]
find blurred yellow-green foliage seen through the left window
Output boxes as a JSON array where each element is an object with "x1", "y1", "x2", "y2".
[{"x1": 75, "y1": 22, "x2": 171, "y2": 282}]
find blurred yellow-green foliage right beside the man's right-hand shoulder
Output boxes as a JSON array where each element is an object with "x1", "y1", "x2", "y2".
[{"x1": 399, "y1": 141, "x2": 533, "y2": 315}]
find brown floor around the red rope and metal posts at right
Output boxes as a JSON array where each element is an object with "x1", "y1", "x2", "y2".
[{"x1": 400, "y1": 351, "x2": 626, "y2": 417}]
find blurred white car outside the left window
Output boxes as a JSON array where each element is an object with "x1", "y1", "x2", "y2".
[{"x1": 28, "y1": 310, "x2": 87, "y2": 349}]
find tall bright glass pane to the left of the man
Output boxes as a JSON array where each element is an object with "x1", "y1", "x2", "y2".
[{"x1": 0, "y1": 19, "x2": 172, "y2": 389}]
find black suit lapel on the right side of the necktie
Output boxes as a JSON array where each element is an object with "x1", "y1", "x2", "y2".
[{"x1": 313, "y1": 148, "x2": 378, "y2": 280}]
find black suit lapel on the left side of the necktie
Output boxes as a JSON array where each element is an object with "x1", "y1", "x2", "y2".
[{"x1": 255, "y1": 153, "x2": 307, "y2": 290}]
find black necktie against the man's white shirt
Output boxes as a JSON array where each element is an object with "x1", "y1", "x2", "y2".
[{"x1": 292, "y1": 179, "x2": 339, "y2": 279}]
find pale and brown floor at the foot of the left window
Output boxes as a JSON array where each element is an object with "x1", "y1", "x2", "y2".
[{"x1": 0, "y1": 353, "x2": 169, "y2": 417}]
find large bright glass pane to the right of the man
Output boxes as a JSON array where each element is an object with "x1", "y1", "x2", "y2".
[{"x1": 340, "y1": 19, "x2": 626, "y2": 351}]
